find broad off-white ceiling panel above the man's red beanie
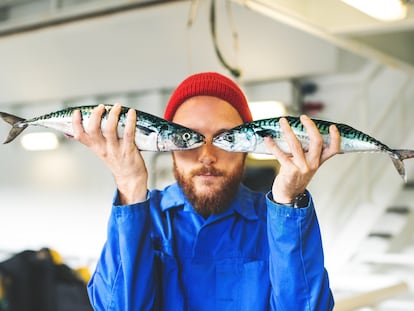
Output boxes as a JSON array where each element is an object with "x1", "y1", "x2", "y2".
[{"x1": 0, "y1": 1, "x2": 370, "y2": 104}]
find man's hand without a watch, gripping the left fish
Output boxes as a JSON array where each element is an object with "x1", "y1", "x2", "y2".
[{"x1": 72, "y1": 104, "x2": 148, "y2": 204}]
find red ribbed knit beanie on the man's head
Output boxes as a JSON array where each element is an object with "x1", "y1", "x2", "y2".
[{"x1": 164, "y1": 72, "x2": 253, "y2": 122}]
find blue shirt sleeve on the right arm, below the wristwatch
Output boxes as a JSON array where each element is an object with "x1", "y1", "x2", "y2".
[{"x1": 267, "y1": 193, "x2": 334, "y2": 311}]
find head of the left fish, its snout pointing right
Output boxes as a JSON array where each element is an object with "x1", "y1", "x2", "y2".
[{"x1": 159, "y1": 126, "x2": 206, "y2": 151}]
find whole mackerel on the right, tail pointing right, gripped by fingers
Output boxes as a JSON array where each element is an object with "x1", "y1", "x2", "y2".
[{"x1": 212, "y1": 116, "x2": 414, "y2": 181}]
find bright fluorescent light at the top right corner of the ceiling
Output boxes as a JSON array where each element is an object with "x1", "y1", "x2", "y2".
[{"x1": 342, "y1": 0, "x2": 407, "y2": 21}]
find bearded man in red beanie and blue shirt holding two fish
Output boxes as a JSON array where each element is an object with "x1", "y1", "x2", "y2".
[{"x1": 73, "y1": 72, "x2": 340, "y2": 311}]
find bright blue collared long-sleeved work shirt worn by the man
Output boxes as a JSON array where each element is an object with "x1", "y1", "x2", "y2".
[{"x1": 88, "y1": 184, "x2": 334, "y2": 311}]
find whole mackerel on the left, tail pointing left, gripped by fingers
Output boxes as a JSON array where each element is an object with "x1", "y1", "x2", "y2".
[{"x1": 0, "y1": 105, "x2": 206, "y2": 151}]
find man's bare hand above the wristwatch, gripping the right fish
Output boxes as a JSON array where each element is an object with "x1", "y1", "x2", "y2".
[{"x1": 266, "y1": 115, "x2": 341, "y2": 203}]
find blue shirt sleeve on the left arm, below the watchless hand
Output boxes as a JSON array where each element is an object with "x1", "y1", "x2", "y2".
[{"x1": 88, "y1": 194, "x2": 156, "y2": 311}]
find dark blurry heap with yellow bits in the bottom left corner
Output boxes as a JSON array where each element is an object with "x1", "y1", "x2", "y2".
[{"x1": 0, "y1": 248, "x2": 93, "y2": 311}]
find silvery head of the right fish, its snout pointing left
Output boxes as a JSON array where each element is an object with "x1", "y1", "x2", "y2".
[{"x1": 212, "y1": 128, "x2": 257, "y2": 152}]
